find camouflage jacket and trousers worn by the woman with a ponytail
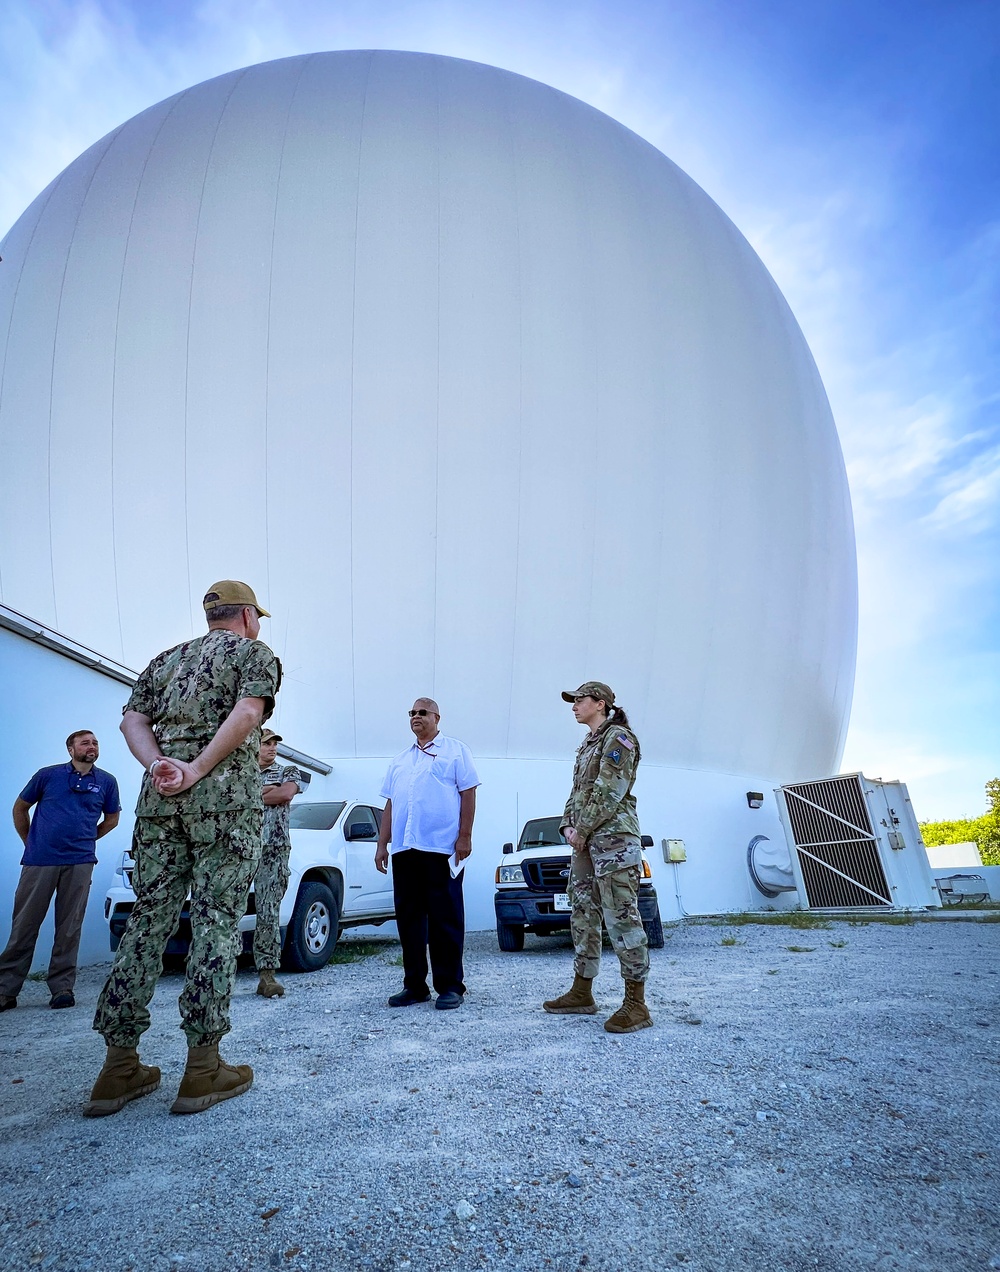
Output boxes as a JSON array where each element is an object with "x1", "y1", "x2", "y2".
[{"x1": 561, "y1": 715, "x2": 649, "y2": 981}]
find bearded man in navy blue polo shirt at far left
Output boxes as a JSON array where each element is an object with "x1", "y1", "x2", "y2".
[{"x1": 0, "y1": 729, "x2": 122, "y2": 1011}]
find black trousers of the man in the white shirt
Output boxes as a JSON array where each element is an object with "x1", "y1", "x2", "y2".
[{"x1": 392, "y1": 848, "x2": 466, "y2": 993}]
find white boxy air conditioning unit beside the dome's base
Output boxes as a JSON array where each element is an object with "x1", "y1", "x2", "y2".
[{"x1": 775, "y1": 773, "x2": 941, "y2": 909}]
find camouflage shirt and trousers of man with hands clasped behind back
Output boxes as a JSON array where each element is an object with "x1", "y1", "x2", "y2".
[{"x1": 94, "y1": 630, "x2": 281, "y2": 1047}]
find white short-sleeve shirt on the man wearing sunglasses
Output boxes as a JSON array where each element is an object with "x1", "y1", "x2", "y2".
[{"x1": 382, "y1": 733, "x2": 480, "y2": 855}]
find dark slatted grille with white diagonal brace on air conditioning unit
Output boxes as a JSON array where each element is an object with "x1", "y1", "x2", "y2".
[{"x1": 781, "y1": 775, "x2": 892, "y2": 909}]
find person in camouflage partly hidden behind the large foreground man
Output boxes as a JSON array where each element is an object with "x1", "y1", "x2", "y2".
[{"x1": 253, "y1": 729, "x2": 304, "y2": 999}]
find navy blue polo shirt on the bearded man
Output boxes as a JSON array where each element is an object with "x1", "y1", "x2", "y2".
[{"x1": 19, "y1": 762, "x2": 122, "y2": 866}]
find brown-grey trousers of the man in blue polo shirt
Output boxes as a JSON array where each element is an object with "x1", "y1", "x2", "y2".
[{"x1": 0, "y1": 861, "x2": 94, "y2": 999}]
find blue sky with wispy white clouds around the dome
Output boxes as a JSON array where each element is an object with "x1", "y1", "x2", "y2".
[{"x1": 0, "y1": 0, "x2": 1000, "y2": 818}]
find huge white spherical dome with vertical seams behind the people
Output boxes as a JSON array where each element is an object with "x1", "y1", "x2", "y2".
[{"x1": 0, "y1": 52, "x2": 856, "y2": 912}]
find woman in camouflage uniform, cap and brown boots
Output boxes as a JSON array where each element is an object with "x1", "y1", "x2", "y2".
[{"x1": 542, "y1": 681, "x2": 653, "y2": 1033}]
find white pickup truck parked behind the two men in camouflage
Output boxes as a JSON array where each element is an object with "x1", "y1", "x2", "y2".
[{"x1": 104, "y1": 799, "x2": 396, "y2": 972}]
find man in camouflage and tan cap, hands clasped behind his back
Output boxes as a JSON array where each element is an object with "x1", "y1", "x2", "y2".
[{"x1": 84, "y1": 580, "x2": 281, "y2": 1117}]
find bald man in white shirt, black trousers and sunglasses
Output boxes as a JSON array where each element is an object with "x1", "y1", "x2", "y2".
[{"x1": 375, "y1": 698, "x2": 480, "y2": 1011}]
